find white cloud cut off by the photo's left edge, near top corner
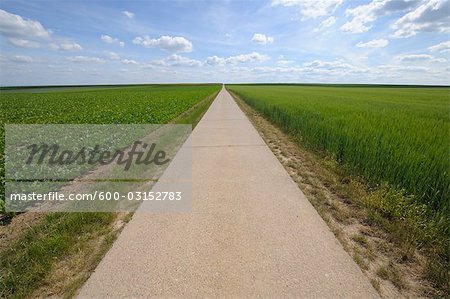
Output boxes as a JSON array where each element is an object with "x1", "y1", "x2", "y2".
[{"x1": 0, "y1": 9, "x2": 51, "y2": 39}]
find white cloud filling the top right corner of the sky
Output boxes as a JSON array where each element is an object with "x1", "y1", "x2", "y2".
[{"x1": 392, "y1": 0, "x2": 450, "y2": 38}]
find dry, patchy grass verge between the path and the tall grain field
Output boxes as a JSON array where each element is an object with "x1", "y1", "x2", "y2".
[{"x1": 231, "y1": 93, "x2": 449, "y2": 298}]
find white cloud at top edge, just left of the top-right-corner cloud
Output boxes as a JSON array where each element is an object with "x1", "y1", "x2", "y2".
[{"x1": 341, "y1": 0, "x2": 418, "y2": 33}]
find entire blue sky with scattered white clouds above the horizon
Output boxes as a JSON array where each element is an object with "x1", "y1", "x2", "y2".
[{"x1": 0, "y1": 0, "x2": 450, "y2": 85}]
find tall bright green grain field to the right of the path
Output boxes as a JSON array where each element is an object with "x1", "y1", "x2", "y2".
[{"x1": 227, "y1": 85, "x2": 450, "y2": 213}]
